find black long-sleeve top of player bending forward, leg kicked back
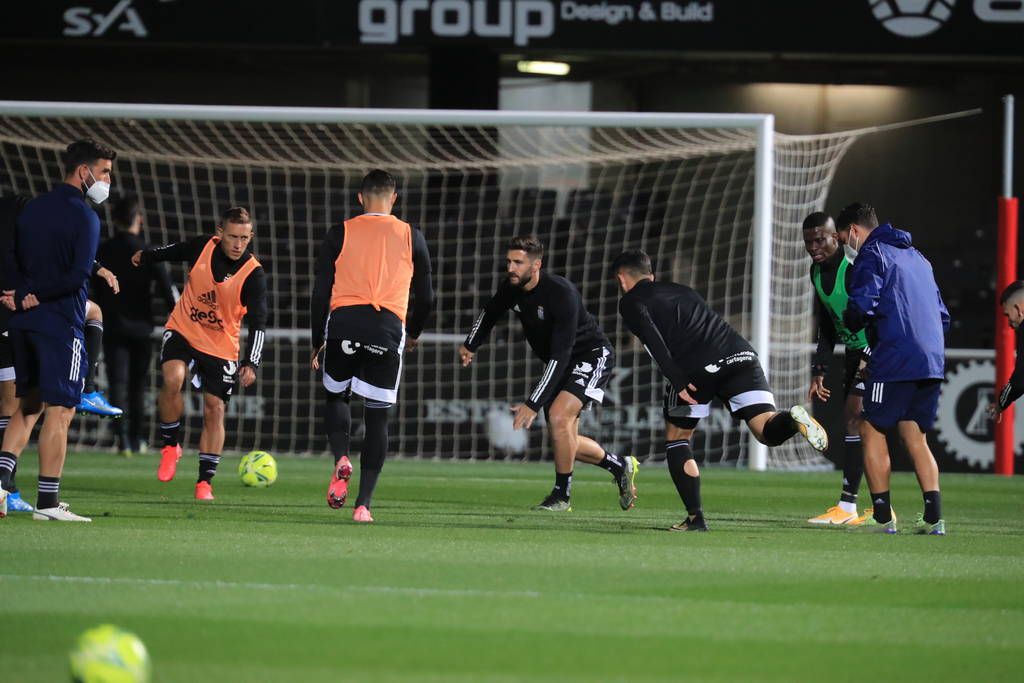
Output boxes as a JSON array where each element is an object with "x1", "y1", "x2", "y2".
[{"x1": 618, "y1": 280, "x2": 757, "y2": 392}]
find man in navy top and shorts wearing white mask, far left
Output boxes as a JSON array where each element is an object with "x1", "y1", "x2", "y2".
[{"x1": 0, "y1": 140, "x2": 117, "y2": 522}]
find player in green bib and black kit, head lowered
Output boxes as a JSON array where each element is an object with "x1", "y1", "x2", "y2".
[{"x1": 804, "y1": 211, "x2": 871, "y2": 525}]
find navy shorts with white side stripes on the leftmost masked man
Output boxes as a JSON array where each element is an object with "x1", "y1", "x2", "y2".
[{"x1": 8, "y1": 328, "x2": 89, "y2": 408}]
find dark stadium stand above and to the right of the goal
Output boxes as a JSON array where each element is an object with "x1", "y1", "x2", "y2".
[{"x1": 0, "y1": 0, "x2": 1024, "y2": 469}]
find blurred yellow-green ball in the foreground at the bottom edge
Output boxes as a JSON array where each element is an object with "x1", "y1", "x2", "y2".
[{"x1": 71, "y1": 624, "x2": 150, "y2": 683}]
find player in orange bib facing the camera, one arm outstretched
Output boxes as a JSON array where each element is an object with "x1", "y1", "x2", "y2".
[{"x1": 132, "y1": 207, "x2": 267, "y2": 501}]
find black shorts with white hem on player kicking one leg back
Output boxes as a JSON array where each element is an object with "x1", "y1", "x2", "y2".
[{"x1": 662, "y1": 358, "x2": 775, "y2": 429}]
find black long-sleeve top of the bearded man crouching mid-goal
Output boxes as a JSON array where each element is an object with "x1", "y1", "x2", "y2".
[{"x1": 465, "y1": 272, "x2": 611, "y2": 411}]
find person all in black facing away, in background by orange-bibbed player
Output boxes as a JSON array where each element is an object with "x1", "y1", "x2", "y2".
[{"x1": 95, "y1": 196, "x2": 176, "y2": 456}]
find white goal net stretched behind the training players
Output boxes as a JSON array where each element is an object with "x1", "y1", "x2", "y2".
[{"x1": 0, "y1": 102, "x2": 856, "y2": 468}]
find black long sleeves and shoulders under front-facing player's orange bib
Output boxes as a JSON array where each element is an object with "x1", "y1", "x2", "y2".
[{"x1": 139, "y1": 234, "x2": 269, "y2": 368}]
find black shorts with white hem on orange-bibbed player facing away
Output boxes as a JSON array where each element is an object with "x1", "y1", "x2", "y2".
[{"x1": 324, "y1": 336, "x2": 406, "y2": 405}]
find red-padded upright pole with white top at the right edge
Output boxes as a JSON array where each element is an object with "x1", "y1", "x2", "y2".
[{"x1": 995, "y1": 95, "x2": 1018, "y2": 475}]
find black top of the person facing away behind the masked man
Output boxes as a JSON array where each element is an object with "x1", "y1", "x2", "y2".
[{"x1": 92, "y1": 230, "x2": 175, "y2": 338}]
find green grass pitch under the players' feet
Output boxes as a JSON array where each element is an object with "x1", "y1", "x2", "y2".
[{"x1": 0, "y1": 454, "x2": 1024, "y2": 683}]
